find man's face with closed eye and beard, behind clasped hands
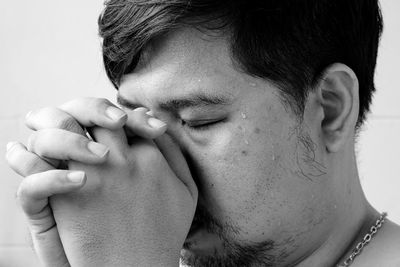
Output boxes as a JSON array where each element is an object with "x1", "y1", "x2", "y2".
[{"x1": 119, "y1": 29, "x2": 335, "y2": 266}]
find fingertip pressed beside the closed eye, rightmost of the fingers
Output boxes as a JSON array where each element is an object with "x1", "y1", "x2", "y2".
[{"x1": 126, "y1": 107, "x2": 167, "y2": 139}]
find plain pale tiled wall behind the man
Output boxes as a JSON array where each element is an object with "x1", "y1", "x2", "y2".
[{"x1": 0, "y1": 0, "x2": 400, "y2": 267}]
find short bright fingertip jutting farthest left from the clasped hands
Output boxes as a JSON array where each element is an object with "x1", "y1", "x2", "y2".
[{"x1": 6, "y1": 142, "x2": 54, "y2": 177}]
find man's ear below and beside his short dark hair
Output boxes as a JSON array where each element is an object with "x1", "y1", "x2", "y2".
[{"x1": 317, "y1": 63, "x2": 359, "y2": 153}]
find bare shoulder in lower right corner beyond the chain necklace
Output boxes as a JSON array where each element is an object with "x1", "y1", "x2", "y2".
[{"x1": 354, "y1": 220, "x2": 400, "y2": 267}]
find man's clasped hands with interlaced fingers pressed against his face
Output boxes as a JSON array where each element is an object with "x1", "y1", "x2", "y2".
[{"x1": 6, "y1": 98, "x2": 198, "y2": 266}]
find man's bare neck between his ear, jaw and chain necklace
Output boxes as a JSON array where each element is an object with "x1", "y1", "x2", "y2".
[{"x1": 297, "y1": 143, "x2": 379, "y2": 267}]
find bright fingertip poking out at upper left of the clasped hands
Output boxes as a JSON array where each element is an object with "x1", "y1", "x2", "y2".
[{"x1": 25, "y1": 107, "x2": 85, "y2": 135}]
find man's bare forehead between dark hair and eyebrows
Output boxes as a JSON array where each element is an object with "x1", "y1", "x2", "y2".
[{"x1": 119, "y1": 28, "x2": 240, "y2": 103}]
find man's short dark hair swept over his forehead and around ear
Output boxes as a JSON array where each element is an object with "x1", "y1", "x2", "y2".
[{"x1": 99, "y1": 0, "x2": 382, "y2": 127}]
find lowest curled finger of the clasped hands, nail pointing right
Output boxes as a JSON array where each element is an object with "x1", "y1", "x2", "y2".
[{"x1": 17, "y1": 170, "x2": 86, "y2": 217}]
